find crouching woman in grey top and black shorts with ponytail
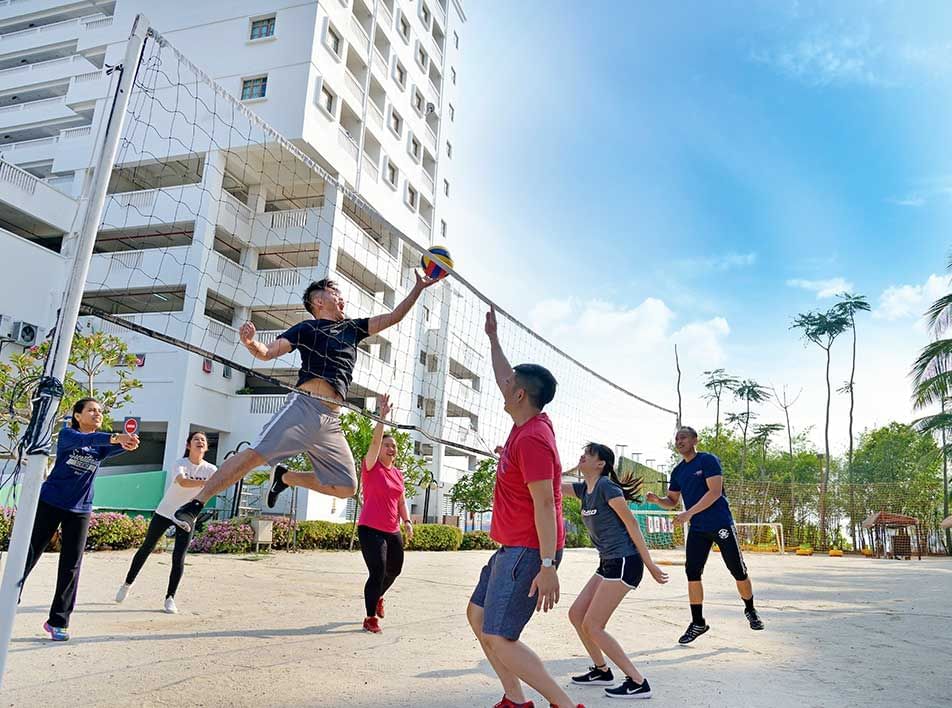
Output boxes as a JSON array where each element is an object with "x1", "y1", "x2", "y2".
[{"x1": 562, "y1": 443, "x2": 668, "y2": 698}]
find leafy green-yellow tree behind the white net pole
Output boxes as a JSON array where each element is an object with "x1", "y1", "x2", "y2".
[{"x1": 0, "y1": 332, "x2": 142, "y2": 457}]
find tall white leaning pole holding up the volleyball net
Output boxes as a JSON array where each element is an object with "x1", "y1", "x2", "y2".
[{"x1": 0, "y1": 15, "x2": 149, "y2": 682}]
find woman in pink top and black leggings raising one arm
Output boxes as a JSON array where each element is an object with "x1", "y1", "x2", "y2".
[{"x1": 357, "y1": 394, "x2": 413, "y2": 633}]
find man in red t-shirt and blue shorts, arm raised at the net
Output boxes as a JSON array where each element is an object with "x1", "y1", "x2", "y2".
[{"x1": 466, "y1": 310, "x2": 575, "y2": 708}]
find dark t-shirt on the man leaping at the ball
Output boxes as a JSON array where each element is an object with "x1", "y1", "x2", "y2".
[{"x1": 278, "y1": 317, "x2": 370, "y2": 398}]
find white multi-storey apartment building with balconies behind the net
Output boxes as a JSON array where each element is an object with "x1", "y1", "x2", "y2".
[{"x1": 0, "y1": 0, "x2": 476, "y2": 519}]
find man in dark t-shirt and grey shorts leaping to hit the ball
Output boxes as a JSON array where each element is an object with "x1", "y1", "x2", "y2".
[{"x1": 173, "y1": 271, "x2": 438, "y2": 531}]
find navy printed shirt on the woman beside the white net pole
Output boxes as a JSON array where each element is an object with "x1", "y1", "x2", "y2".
[{"x1": 40, "y1": 428, "x2": 125, "y2": 513}]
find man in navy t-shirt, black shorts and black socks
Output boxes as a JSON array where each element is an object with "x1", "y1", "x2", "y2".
[{"x1": 646, "y1": 426, "x2": 764, "y2": 644}]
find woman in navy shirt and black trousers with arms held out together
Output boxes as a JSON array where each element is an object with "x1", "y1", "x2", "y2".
[{"x1": 21, "y1": 398, "x2": 139, "y2": 642}]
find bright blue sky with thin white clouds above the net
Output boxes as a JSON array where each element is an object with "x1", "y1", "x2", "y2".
[{"x1": 449, "y1": 0, "x2": 952, "y2": 454}]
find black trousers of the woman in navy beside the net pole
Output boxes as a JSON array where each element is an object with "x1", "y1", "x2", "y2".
[{"x1": 20, "y1": 499, "x2": 90, "y2": 627}]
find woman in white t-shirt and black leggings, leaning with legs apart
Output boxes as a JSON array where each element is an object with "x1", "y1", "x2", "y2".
[{"x1": 116, "y1": 432, "x2": 217, "y2": 614}]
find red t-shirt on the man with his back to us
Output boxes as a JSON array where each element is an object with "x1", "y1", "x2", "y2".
[{"x1": 489, "y1": 413, "x2": 565, "y2": 548}]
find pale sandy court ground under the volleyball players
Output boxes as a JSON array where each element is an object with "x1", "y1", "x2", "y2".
[{"x1": 2, "y1": 550, "x2": 952, "y2": 708}]
